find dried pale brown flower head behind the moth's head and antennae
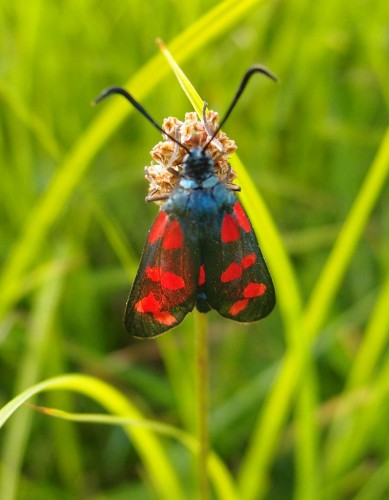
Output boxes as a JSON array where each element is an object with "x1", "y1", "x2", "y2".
[{"x1": 145, "y1": 110, "x2": 237, "y2": 203}]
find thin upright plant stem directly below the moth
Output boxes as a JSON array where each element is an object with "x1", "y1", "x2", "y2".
[{"x1": 195, "y1": 311, "x2": 209, "y2": 500}]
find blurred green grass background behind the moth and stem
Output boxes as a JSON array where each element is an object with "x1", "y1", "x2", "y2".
[{"x1": 0, "y1": 0, "x2": 389, "y2": 500}]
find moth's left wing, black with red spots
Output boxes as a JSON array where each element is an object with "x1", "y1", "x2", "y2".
[{"x1": 124, "y1": 210, "x2": 200, "y2": 338}]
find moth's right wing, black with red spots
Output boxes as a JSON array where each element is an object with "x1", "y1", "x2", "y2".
[{"x1": 203, "y1": 200, "x2": 275, "y2": 322}]
